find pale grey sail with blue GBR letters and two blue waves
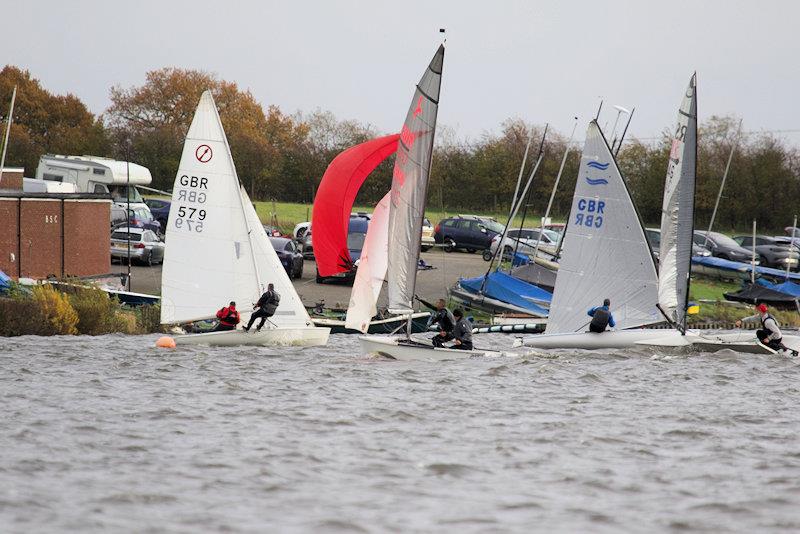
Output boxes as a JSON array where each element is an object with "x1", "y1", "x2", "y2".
[{"x1": 546, "y1": 121, "x2": 662, "y2": 333}]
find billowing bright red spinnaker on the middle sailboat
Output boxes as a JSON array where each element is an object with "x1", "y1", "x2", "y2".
[{"x1": 311, "y1": 134, "x2": 400, "y2": 276}]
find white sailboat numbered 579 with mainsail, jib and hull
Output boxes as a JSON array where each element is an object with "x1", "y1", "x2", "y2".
[{"x1": 161, "y1": 91, "x2": 330, "y2": 346}]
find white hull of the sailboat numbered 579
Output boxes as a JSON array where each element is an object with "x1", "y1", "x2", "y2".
[{"x1": 174, "y1": 327, "x2": 331, "y2": 347}]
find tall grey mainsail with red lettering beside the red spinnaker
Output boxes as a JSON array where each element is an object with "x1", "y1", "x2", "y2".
[{"x1": 388, "y1": 45, "x2": 444, "y2": 313}]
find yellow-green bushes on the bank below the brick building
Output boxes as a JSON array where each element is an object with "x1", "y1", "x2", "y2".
[{"x1": 0, "y1": 284, "x2": 161, "y2": 336}]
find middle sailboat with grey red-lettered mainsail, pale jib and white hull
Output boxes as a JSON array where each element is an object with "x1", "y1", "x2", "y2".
[{"x1": 348, "y1": 45, "x2": 496, "y2": 360}]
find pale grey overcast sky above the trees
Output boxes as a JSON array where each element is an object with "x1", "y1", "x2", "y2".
[{"x1": 6, "y1": 0, "x2": 800, "y2": 143}]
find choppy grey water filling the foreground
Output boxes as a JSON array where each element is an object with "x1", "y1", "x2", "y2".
[{"x1": 0, "y1": 335, "x2": 800, "y2": 532}]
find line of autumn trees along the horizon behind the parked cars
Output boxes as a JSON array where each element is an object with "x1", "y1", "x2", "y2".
[{"x1": 0, "y1": 66, "x2": 800, "y2": 231}]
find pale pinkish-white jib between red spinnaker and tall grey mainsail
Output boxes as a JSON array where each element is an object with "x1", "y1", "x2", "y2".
[{"x1": 345, "y1": 193, "x2": 391, "y2": 334}]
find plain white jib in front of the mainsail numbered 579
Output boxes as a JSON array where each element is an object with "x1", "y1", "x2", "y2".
[{"x1": 239, "y1": 187, "x2": 311, "y2": 327}]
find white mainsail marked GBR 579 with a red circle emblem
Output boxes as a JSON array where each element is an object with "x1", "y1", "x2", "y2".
[{"x1": 161, "y1": 91, "x2": 258, "y2": 323}]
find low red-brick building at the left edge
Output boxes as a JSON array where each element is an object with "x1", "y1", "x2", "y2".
[{"x1": 0, "y1": 194, "x2": 111, "y2": 284}]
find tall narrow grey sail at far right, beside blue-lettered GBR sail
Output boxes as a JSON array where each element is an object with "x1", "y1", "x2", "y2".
[{"x1": 658, "y1": 74, "x2": 697, "y2": 330}]
